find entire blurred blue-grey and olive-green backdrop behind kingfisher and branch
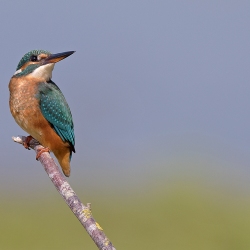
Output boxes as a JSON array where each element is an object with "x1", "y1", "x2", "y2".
[{"x1": 0, "y1": 0, "x2": 250, "y2": 250}]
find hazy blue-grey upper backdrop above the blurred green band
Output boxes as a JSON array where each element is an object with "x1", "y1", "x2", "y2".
[{"x1": 0, "y1": 0, "x2": 250, "y2": 189}]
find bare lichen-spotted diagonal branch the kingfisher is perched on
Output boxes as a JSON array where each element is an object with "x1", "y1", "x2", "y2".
[{"x1": 12, "y1": 136, "x2": 115, "y2": 250}]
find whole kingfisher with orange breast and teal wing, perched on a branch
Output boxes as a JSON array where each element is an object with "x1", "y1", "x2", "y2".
[{"x1": 9, "y1": 50, "x2": 75, "y2": 177}]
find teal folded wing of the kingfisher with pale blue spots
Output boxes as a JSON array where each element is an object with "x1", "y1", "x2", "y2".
[{"x1": 38, "y1": 81, "x2": 75, "y2": 152}]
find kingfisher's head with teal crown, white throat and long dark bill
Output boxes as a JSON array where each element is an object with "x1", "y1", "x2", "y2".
[{"x1": 14, "y1": 50, "x2": 75, "y2": 81}]
